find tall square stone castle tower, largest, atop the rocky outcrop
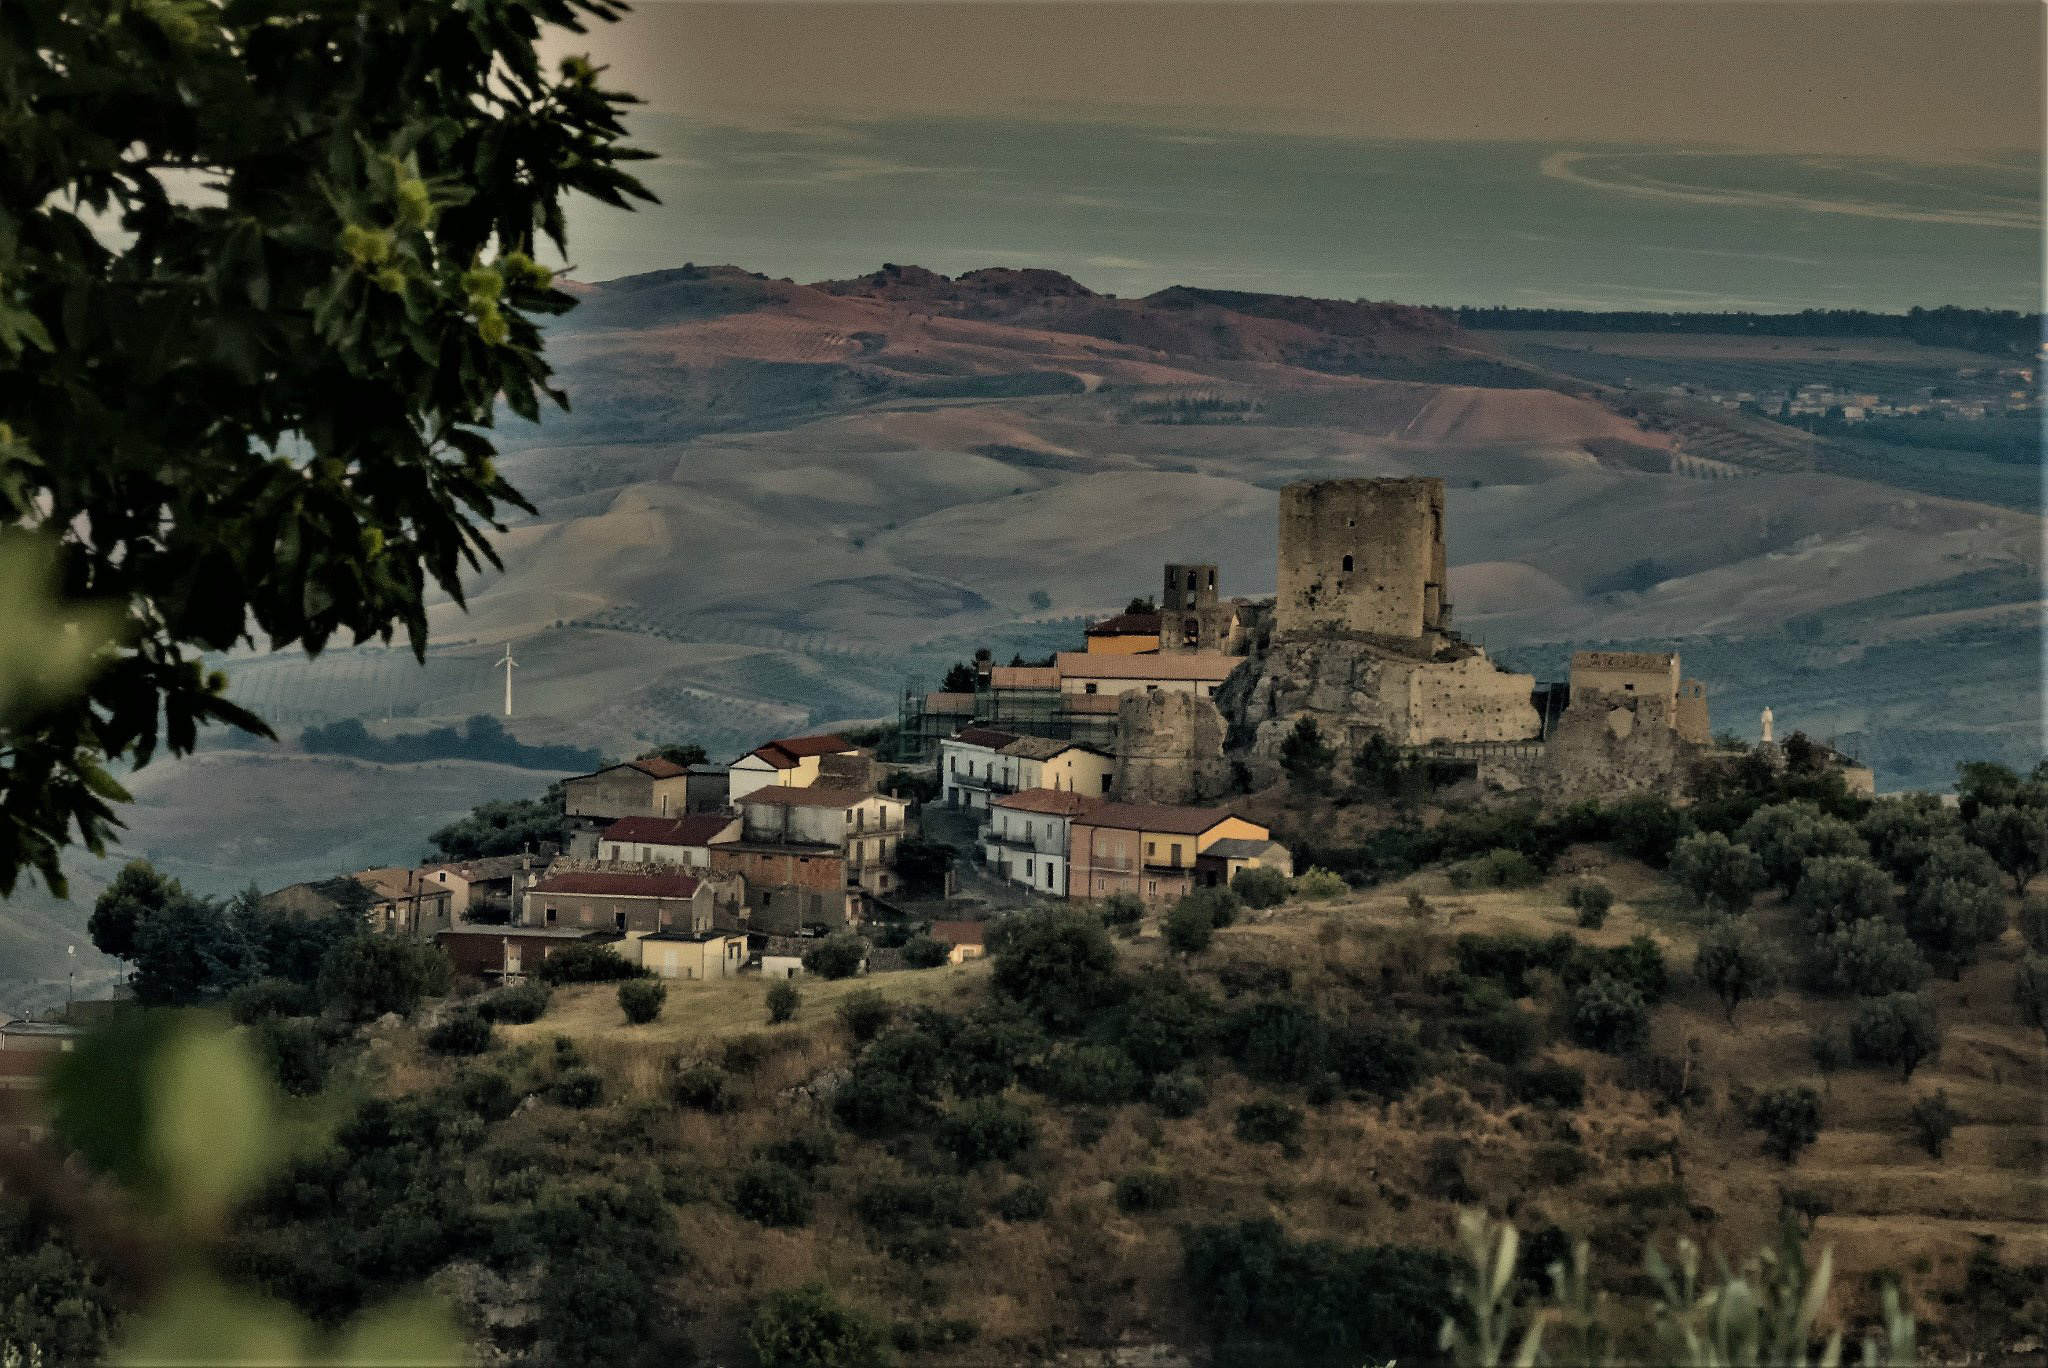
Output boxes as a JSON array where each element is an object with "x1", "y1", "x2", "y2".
[{"x1": 1274, "y1": 477, "x2": 1450, "y2": 641}]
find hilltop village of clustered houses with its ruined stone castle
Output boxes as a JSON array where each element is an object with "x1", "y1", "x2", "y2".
[{"x1": 266, "y1": 479, "x2": 1870, "y2": 981}]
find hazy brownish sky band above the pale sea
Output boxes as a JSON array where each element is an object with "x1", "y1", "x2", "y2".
[{"x1": 555, "y1": 0, "x2": 2044, "y2": 158}]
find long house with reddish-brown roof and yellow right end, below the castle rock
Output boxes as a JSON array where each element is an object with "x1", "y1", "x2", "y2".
[{"x1": 1067, "y1": 801, "x2": 1272, "y2": 903}]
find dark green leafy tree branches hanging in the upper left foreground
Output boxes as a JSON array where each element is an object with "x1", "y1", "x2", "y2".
[{"x1": 0, "y1": 0, "x2": 649, "y2": 893}]
